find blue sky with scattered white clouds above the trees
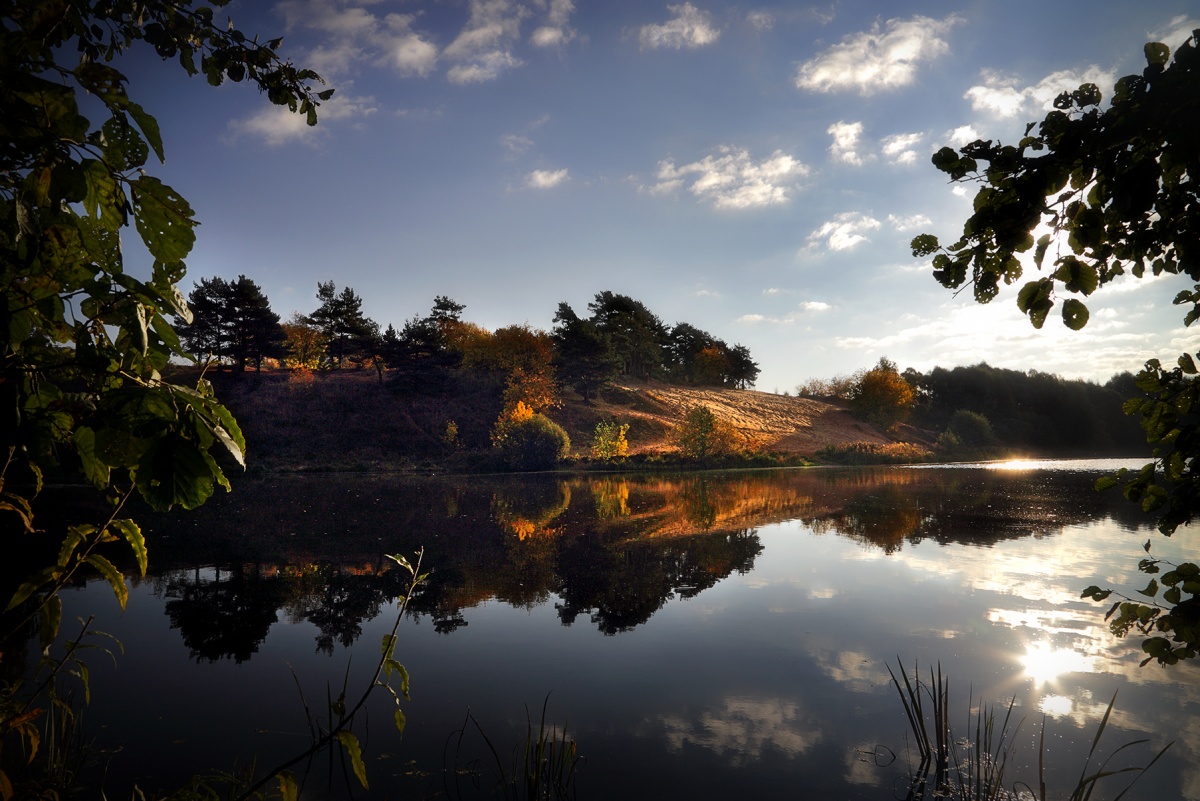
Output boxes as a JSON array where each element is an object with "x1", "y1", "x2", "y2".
[{"x1": 116, "y1": 0, "x2": 1200, "y2": 392}]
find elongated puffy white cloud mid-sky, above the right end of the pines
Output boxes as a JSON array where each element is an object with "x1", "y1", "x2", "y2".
[{"x1": 649, "y1": 146, "x2": 809, "y2": 209}]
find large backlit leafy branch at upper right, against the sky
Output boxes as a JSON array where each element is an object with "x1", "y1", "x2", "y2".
[{"x1": 912, "y1": 34, "x2": 1200, "y2": 330}]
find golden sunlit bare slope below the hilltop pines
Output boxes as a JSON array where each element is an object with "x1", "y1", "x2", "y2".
[{"x1": 580, "y1": 381, "x2": 894, "y2": 454}]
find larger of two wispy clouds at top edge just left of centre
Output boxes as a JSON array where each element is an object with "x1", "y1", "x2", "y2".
[{"x1": 442, "y1": 0, "x2": 529, "y2": 84}]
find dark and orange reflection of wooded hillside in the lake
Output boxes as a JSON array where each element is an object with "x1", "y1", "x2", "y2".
[{"x1": 131, "y1": 468, "x2": 1145, "y2": 660}]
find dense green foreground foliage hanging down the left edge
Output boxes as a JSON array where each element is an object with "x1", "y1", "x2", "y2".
[{"x1": 0, "y1": 0, "x2": 331, "y2": 797}]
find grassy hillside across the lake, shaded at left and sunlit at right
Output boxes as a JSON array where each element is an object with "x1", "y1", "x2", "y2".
[{"x1": 201, "y1": 371, "x2": 902, "y2": 470}]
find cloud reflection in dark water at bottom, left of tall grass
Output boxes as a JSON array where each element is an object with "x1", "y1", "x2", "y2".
[{"x1": 660, "y1": 697, "x2": 822, "y2": 767}]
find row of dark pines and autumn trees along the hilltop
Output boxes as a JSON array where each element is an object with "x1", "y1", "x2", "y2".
[{"x1": 178, "y1": 276, "x2": 760, "y2": 398}]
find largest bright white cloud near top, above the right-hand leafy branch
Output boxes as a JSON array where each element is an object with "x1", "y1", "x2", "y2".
[{"x1": 796, "y1": 17, "x2": 959, "y2": 95}]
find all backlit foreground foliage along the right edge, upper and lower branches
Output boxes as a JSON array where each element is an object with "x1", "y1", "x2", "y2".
[{"x1": 912, "y1": 31, "x2": 1200, "y2": 664}]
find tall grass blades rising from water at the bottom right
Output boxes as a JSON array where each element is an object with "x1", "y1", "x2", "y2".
[{"x1": 888, "y1": 662, "x2": 1172, "y2": 801}]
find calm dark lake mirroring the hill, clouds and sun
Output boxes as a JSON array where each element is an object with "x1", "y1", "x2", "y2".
[{"x1": 46, "y1": 462, "x2": 1200, "y2": 800}]
